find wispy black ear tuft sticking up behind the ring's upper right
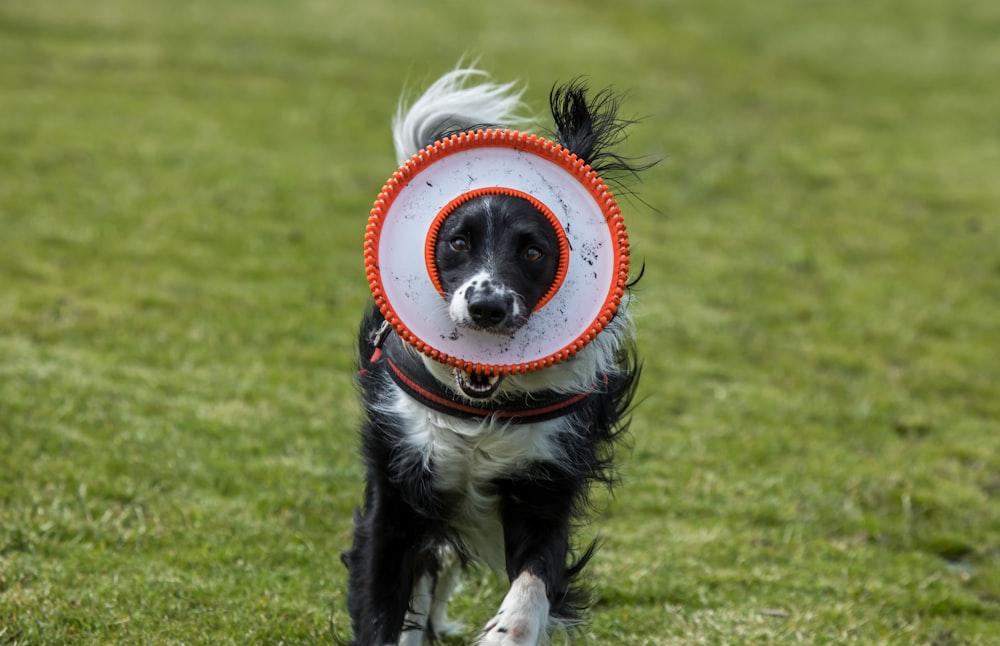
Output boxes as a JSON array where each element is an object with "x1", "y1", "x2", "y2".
[{"x1": 549, "y1": 78, "x2": 652, "y2": 189}]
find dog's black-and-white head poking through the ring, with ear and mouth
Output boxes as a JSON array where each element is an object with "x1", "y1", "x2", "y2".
[{"x1": 410, "y1": 80, "x2": 639, "y2": 399}]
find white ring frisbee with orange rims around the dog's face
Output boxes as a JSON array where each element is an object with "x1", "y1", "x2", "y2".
[{"x1": 364, "y1": 129, "x2": 629, "y2": 375}]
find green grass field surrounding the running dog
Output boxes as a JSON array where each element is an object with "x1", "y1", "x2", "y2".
[{"x1": 0, "y1": 0, "x2": 1000, "y2": 646}]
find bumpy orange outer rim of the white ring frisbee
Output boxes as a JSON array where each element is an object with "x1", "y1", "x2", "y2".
[{"x1": 364, "y1": 129, "x2": 629, "y2": 375}]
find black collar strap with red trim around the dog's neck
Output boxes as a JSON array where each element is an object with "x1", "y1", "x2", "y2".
[{"x1": 369, "y1": 334, "x2": 598, "y2": 424}]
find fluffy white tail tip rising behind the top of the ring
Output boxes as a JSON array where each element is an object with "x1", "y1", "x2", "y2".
[{"x1": 392, "y1": 64, "x2": 526, "y2": 164}]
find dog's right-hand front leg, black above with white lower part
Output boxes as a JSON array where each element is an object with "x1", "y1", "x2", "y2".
[{"x1": 479, "y1": 474, "x2": 577, "y2": 646}]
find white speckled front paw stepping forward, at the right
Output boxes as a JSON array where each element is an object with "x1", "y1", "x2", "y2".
[{"x1": 478, "y1": 573, "x2": 549, "y2": 646}]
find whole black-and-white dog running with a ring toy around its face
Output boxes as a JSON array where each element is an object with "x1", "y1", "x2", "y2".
[{"x1": 343, "y1": 69, "x2": 638, "y2": 646}]
